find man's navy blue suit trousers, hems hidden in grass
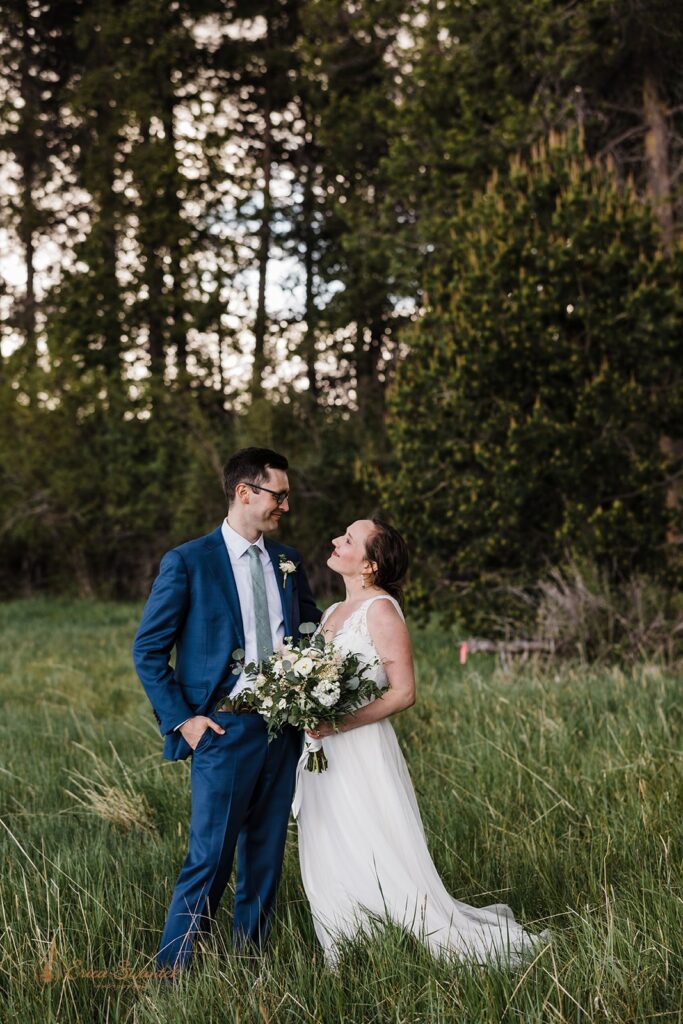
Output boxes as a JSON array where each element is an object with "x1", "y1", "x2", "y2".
[{"x1": 157, "y1": 712, "x2": 301, "y2": 971}]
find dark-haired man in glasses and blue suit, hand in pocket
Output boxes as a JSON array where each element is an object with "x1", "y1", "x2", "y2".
[{"x1": 133, "y1": 447, "x2": 321, "y2": 974}]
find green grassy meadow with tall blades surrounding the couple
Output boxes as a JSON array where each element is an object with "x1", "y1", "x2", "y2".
[{"x1": 0, "y1": 599, "x2": 683, "y2": 1024}]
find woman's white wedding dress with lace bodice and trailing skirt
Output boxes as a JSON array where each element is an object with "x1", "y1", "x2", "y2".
[{"x1": 293, "y1": 595, "x2": 549, "y2": 966}]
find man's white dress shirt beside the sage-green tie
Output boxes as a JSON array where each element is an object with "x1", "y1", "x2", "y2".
[{"x1": 173, "y1": 517, "x2": 285, "y2": 732}]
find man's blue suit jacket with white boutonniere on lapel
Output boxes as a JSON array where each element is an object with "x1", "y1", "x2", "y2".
[{"x1": 133, "y1": 526, "x2": 322, "y2": 761}]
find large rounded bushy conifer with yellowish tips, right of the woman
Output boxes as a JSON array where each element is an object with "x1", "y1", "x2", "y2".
[{"x1": 384, "y1": 138, "x2": 683, "y2": 623}]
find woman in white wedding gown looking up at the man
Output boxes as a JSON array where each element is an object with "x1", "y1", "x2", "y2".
[{"x1": 293, "y1": 519, "x2": 549, "y2": 966}]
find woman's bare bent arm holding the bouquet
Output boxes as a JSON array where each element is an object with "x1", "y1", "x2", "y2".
[{"x1": 307, "y1": 601, "x2": 415, "y2": 737}]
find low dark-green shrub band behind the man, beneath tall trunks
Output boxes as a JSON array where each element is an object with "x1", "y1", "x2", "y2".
[{"x1": 0, "y1": 379, "x2": 372, "y2": 597}]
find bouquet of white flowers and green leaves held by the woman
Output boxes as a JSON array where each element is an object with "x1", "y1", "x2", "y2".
[{"x1": 232, "y1": 623, "x2": 384, "y2": 772}]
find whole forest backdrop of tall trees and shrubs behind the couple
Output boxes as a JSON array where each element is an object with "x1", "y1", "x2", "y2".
[{"x1": 0, "y1": 0, "x2": 683, "y2": 650}]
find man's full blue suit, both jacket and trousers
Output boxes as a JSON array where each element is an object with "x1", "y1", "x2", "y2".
[{"x1": 133, "y1": 526, "x2": 321, "y2": 969}]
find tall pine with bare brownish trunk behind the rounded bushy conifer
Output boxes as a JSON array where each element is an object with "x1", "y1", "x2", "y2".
[{"x1": 384, "y1": 0, "x2": 683, "y2": 300}]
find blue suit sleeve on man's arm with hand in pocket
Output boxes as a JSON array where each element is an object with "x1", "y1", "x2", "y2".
[{"x1": 133, "y1": 551, "x2": 193, "y2": 735}]
